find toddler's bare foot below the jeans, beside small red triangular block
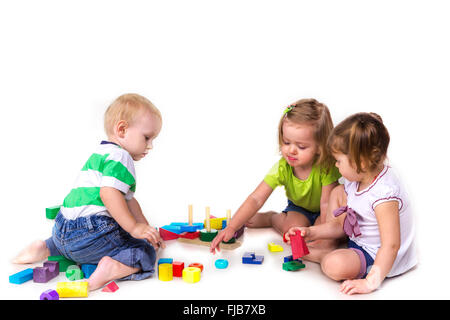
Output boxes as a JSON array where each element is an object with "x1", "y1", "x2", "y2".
[{"x1": 88, "y1": 256, "x2": 139, "y2": 291}]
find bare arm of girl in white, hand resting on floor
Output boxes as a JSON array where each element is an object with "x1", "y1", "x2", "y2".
[{"x1": 341, "y1": 201, "x2": 400, "y2": 294}]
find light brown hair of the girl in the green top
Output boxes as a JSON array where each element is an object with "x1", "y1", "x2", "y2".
[{"x1": 278, "y1": 99, "x2": 335, "y2": 172}]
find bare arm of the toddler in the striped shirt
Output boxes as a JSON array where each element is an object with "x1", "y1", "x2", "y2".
[{"x1": 100, "y1": 187, "x2": 162, "y2": 248}]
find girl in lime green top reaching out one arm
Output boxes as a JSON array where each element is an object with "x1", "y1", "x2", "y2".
[{"x1": 210, "y1": 99, "x2": 340, "y2": 253}]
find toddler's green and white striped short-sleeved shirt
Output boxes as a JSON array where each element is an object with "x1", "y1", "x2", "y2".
[{"x1": 61, "y1": 141, "x2": 136, "y2": 219}]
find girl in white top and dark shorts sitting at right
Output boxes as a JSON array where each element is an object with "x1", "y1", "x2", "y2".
[{"x1": 285, "y1": 113, "x2": 417, "y2": 294}]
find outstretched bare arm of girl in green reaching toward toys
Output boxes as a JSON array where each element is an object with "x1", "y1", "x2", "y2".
[{"x1": 210, "y1": 181, "x2": 273, "y2": 253}]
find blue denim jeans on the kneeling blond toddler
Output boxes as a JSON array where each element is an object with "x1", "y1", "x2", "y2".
[{"x1": 45, "y1": 213, "x2": 156, "y2": 280}]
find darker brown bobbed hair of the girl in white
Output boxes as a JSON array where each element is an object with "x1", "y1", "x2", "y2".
[{"x1": 328, "y1": 112, "x2": 390, "y2": 173}]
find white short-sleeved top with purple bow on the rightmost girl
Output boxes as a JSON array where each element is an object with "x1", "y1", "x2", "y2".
[{"x1": 344, "y1": 166, "x2": 417, "y2": 277}]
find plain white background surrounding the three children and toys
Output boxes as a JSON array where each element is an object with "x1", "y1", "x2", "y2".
[{"x1": 0, "y1": 0, "x2": 450, "y2": 299}]
